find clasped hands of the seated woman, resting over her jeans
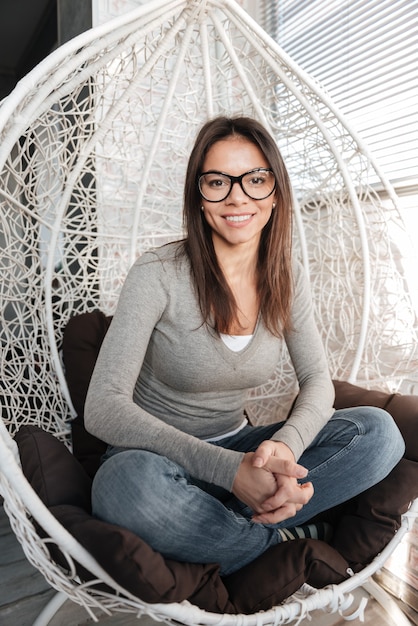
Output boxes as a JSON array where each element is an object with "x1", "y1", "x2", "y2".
[{"x1": 232, "y1": 440, "x2": 314, "y2": 524}]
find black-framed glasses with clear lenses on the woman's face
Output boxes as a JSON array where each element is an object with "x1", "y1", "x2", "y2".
[{"x1": 198, "y1": 167, "x2": 276, "y2": 202}]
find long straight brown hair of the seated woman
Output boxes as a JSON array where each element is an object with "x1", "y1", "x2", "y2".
[{"x1": 183, "y1": 117, "x2": 293, "y2": 336}]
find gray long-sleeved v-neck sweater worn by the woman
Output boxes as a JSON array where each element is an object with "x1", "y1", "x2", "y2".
[{"x1": 85, "y1": 244, "x2": 334, "y2": 490}]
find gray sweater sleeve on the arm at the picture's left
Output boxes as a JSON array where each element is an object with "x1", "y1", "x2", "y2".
[{"x1": 85, "y1": 254, "x2": 243, "y2": 491}]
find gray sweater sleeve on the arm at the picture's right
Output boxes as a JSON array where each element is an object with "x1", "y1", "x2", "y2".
[{"x1": 272, "y1": 263, "x2": 334, "y2": 460}]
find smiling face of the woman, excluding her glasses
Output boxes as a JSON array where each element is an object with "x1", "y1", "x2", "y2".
[{"x1": 202, "y1": 136, "x2": 275, "y2": 249}]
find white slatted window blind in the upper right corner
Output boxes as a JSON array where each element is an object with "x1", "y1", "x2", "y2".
[{"x1": 271, "y1": 0, "x2": 418, "y2": 189}]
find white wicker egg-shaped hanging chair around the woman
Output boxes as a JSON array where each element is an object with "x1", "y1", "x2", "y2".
[{"x1": 0, "y1": 0, "x2": 418, "y2": 626}]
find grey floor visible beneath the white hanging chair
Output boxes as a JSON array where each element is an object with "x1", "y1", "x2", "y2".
[{"x1": 0, "y1": 508, "x2": 418, "y2": 626}]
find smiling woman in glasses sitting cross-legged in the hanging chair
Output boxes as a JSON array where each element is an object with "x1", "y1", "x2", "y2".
[{"x1": 85, "y1": 117, "x2": 404, "y2": 575}]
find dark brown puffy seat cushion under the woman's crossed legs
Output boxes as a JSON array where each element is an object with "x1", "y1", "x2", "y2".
[{"x1": 15, "y1": 398, "x2": 418, "y2": 613}]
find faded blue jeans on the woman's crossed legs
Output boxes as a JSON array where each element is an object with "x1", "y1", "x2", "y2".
[{"x1": 92, "y1": 407, "x2": 404, "y2": 575}]
